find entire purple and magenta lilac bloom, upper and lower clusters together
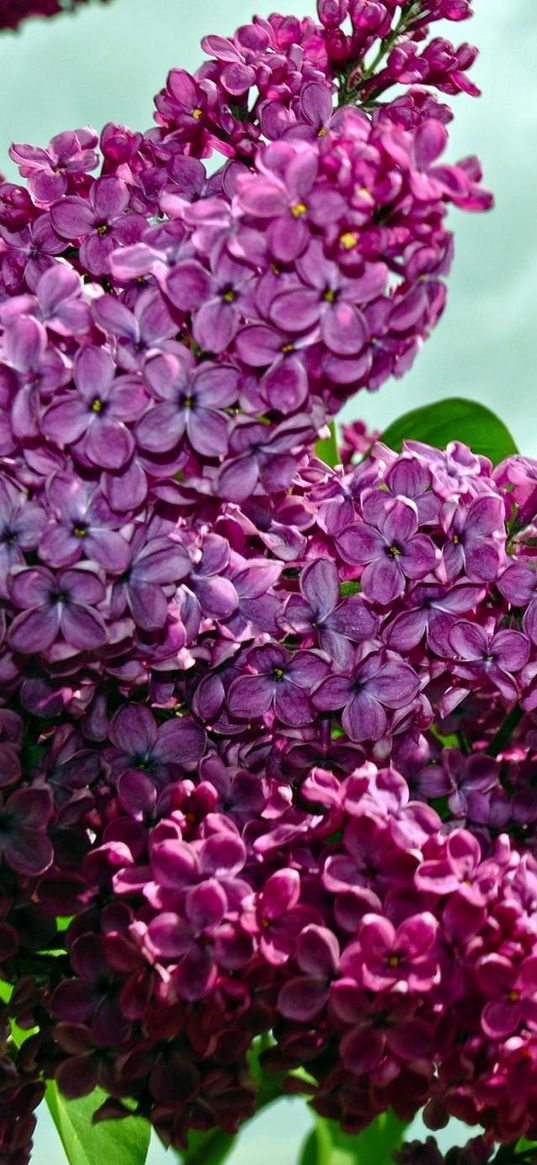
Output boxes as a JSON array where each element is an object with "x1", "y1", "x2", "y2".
[{"x1": 0, "y1": 0, "x2": 528, "y2": 1165}]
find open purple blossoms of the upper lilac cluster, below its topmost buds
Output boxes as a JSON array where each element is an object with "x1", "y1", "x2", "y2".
[{"x1": 0, "y1": 108, "x2": 489, "y2": 509}]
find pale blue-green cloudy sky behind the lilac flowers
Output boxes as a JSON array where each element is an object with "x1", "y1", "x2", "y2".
[{"x1": 0, "y1": 0, "x2": 537, "y2": 1165}]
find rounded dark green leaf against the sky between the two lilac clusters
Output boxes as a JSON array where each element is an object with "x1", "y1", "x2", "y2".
[{"x1": 381, "y1": 396, "x2": 518, "y2": 465}]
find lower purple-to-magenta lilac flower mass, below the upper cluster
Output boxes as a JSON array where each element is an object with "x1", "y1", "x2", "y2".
[{"x1": 1, "y1": 438, "x2": 537, "y2": 1145}]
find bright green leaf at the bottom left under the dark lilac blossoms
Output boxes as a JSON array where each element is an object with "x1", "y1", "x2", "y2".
[{"x1": 45, "y1": 1080, "x2": 151, "y2": 1165}]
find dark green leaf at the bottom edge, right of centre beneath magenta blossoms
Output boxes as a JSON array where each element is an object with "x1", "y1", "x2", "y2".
[{"x1": 299, "y1": 1111, "x2": 407, "y2": 1165}]
